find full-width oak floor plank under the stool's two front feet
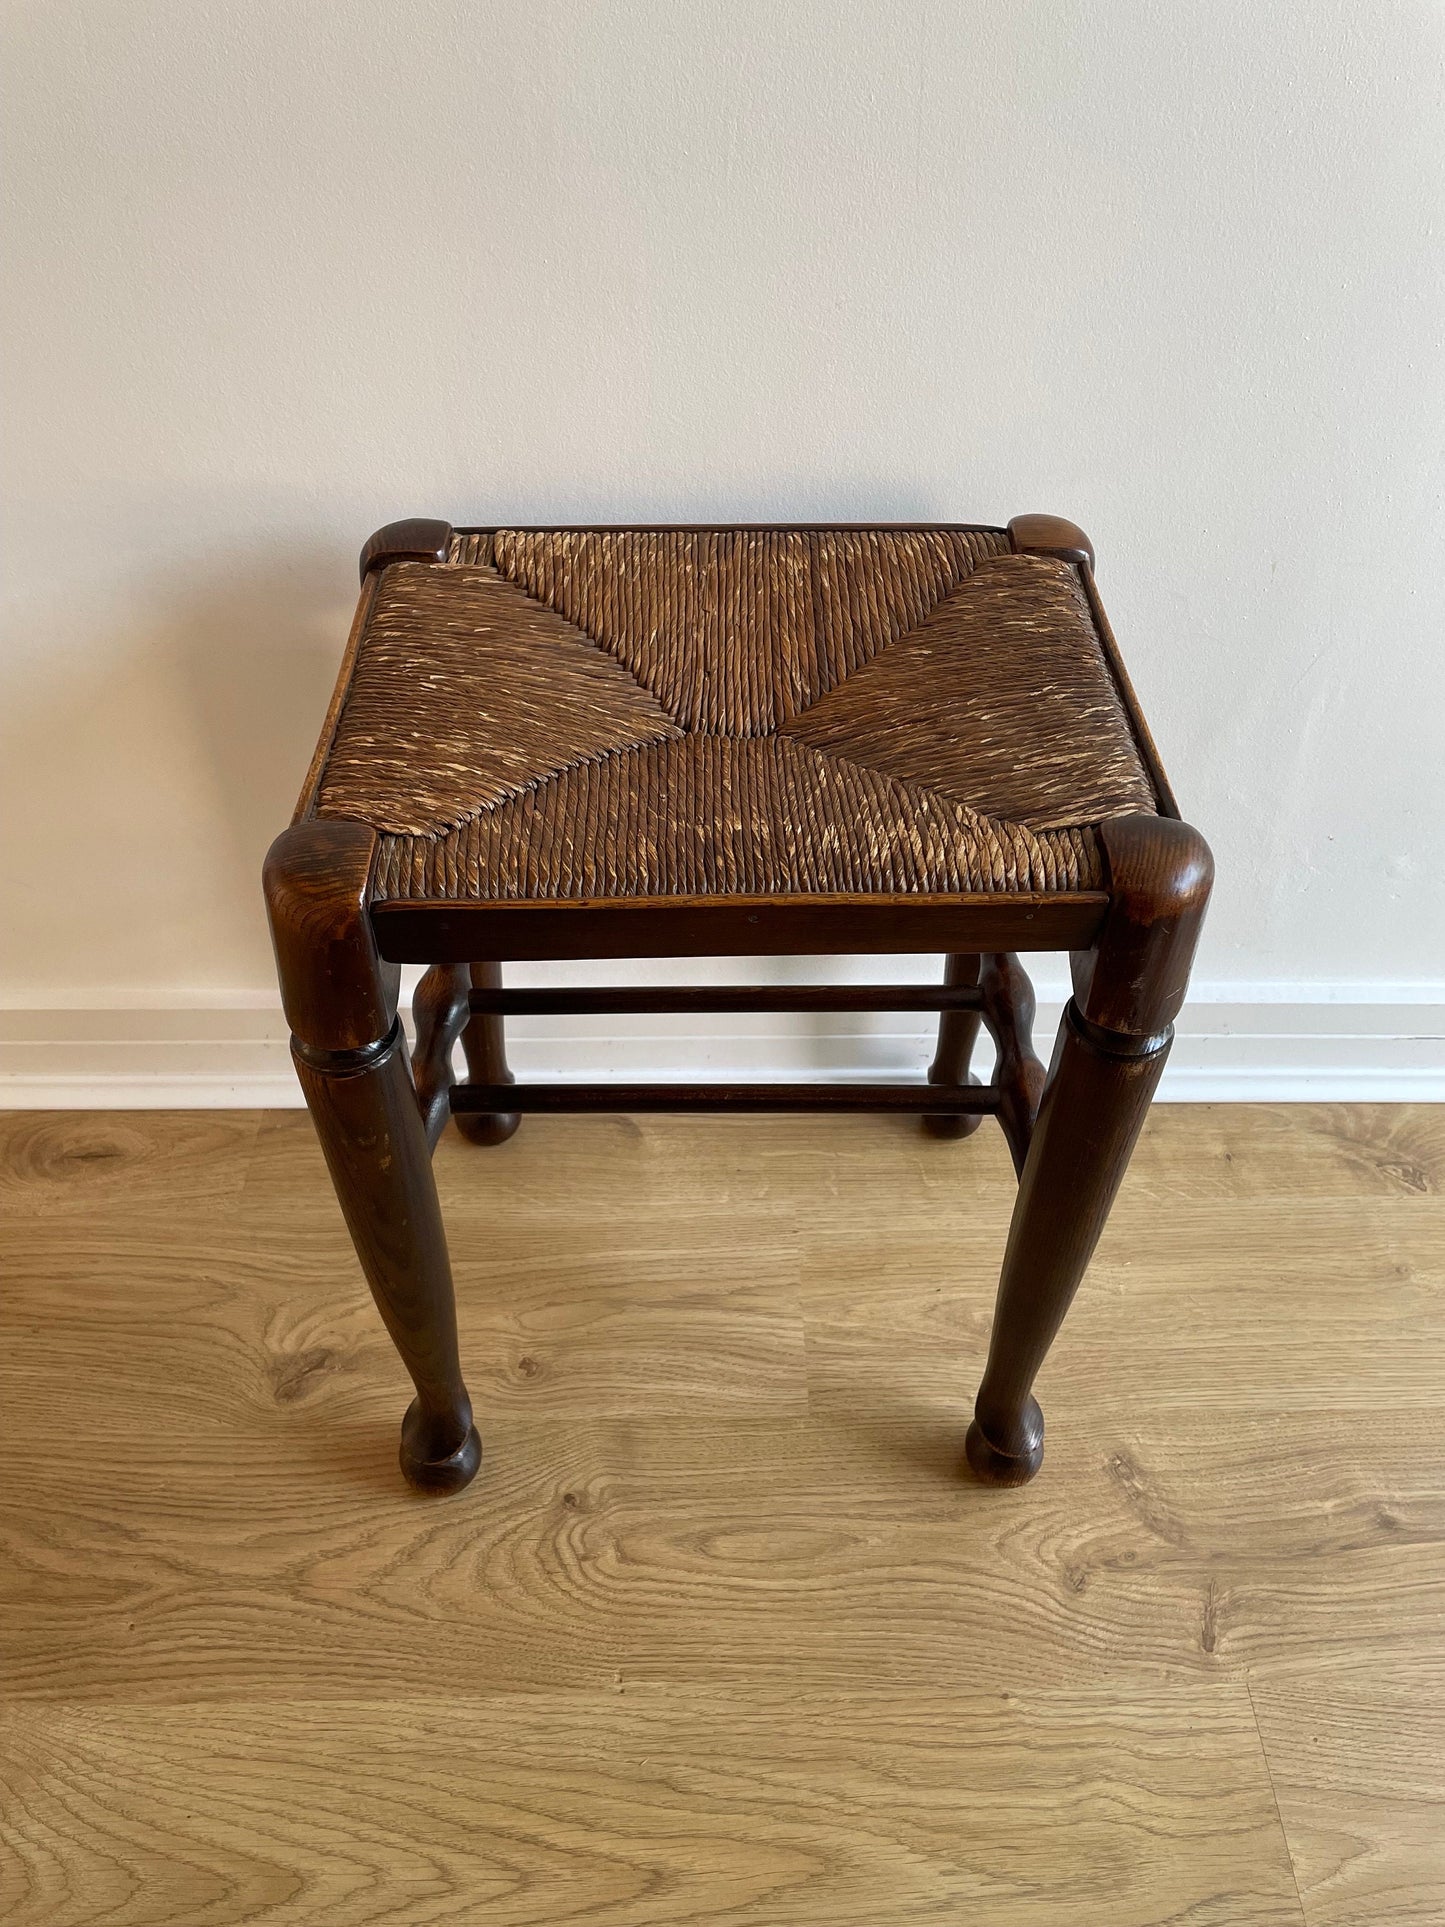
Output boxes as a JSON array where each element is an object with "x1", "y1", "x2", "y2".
[{"x1": 0, "y1": 1386, "x2": 1445, "y2": 1702}]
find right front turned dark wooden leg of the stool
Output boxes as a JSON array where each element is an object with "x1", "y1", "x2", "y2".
[{"x1": 967, "y1": 817, "x2": 1212, "y2": 1486}]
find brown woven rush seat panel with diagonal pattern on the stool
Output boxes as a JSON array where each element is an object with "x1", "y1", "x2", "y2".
[{"x1": 314, "y1": 530, "x2": 1156, "y2": 902}]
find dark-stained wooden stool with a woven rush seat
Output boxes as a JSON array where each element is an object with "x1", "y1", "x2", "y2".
[{"x1": 266, "y1": 515, "x2": 1212, "y2": 1491}]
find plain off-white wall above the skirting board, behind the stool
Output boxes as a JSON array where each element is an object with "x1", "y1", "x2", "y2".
[{"x1": 0, "y1": 0, "x2": 1445, "y2": 1102}]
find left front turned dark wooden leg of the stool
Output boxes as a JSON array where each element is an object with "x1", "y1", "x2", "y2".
[{"x1": 266, "y1": 821, "x2": 482, "y2": 1491}]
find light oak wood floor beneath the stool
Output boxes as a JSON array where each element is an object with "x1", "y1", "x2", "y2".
[{"x1": 0, "y1": 1106, "x2": 1445, "y2": 1927}]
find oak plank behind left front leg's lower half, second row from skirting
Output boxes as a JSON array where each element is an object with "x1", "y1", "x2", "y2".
[{"x1": 0, "y1": 1201, "x2": 805, "y2": 1438}]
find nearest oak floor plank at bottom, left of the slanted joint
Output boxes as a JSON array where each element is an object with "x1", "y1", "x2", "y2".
[{"x1": 0, "y1": 1686, "x2": 1301, "y2": 1927}]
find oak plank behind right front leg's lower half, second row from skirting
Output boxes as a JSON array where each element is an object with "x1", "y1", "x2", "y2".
[{"x1": 801, "y1": 1193, "x2": 1445, "y2": 1422}]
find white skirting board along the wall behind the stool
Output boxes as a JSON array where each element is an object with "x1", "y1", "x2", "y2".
[{"x1": 0, "y1": 969, "x2": 1445, "y2": 1110}]
